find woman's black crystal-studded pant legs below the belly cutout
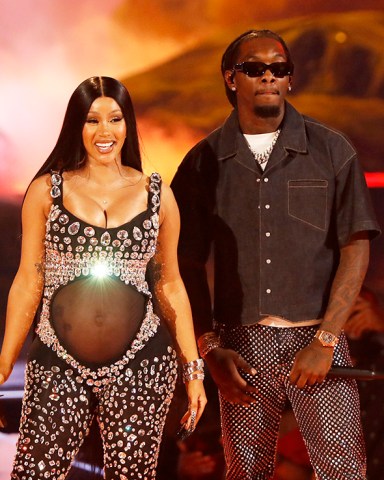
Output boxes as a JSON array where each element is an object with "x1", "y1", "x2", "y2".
[{"x1": 11, "y1": 326, "x2": 177, "y2": 480}]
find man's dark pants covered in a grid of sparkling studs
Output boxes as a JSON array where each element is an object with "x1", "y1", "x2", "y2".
[{"x1": 220, "y1": 325, "x2": 366, "y2": 480}]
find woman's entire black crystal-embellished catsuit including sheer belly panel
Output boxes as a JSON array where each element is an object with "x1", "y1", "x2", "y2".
[{"x1": 12, "y1": 173, "x2": 177, "y2": 480}]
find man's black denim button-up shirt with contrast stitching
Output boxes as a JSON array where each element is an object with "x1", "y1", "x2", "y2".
[{"x1": 171, "y1": 103, "x2": 380, "y2": 335}]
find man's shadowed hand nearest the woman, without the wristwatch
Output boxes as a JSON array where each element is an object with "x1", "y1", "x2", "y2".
[{"x1": 205, "y1": 347, "x2": 257, "y2": 406}]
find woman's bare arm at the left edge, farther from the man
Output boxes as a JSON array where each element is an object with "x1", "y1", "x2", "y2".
[{"x1": 0, "y1": 176, "x2": 50, "y2": 384}]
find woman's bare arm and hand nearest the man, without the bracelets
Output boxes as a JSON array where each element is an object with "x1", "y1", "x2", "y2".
[{"x1": 154, "y1": 185, "x2": 207, "y2": 424}]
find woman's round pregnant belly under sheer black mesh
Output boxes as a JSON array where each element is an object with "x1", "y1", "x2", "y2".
[{"x1": 51, "y1": 277, "x2": 145, "y2": 366}]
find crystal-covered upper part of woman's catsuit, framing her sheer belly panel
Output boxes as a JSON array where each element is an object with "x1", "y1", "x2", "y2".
[{"x1": 37, "y1": 173, "x2": 161, "y2": 388}]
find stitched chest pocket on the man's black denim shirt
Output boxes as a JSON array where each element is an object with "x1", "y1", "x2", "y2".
[{"x1": 288, "y1": 180, "x2": 328, "y2": 231}]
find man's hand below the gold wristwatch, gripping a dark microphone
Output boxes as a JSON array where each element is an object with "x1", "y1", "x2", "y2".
[{"x1": 289, "y1": 339, "x2": 333, "y2": 388}]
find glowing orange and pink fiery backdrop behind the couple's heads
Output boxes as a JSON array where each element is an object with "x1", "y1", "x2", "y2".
[{"x1": 0, "y1": 0, "x2": 384, "y2": 198}]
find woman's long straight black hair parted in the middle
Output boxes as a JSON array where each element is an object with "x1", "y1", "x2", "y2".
[{"x1": 34, "y1": 77, "x2": 142, "y2": 179}]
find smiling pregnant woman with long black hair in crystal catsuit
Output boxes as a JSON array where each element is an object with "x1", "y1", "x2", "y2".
[{"x1": 0, "y1": 77, "x2": 206, "y2": 480}]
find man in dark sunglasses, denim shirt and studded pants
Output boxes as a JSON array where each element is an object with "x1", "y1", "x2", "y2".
[{"x1": 172, "y1": 30, "x2": 379, "y2": 480}]
